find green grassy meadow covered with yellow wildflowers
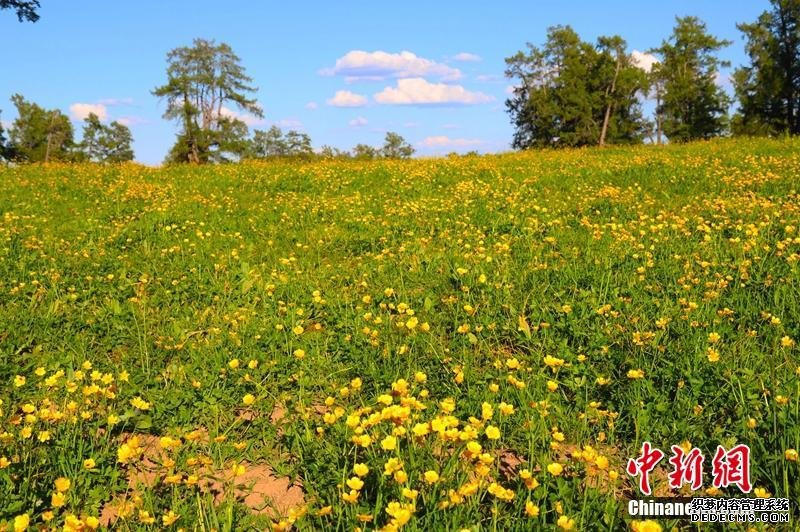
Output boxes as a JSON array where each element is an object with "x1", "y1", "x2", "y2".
[{"x1": 0, "y1": 139, "x2": 800, "y2": 531}]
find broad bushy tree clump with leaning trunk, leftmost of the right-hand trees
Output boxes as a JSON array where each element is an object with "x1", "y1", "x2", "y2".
[{"x1": 506, "y1": 26, "x2": 646, "y2": 149}]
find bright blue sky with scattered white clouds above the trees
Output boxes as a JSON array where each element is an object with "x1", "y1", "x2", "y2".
[{"x1": 0, "y1": 0, "x2": 768, "y2": 164}]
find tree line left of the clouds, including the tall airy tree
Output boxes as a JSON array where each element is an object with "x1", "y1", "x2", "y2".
[{"x1": 0, "y1": 39, "x2": 414, "y2": 164}]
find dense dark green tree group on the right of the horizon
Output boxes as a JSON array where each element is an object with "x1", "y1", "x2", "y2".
[{"x1": 506, "y1": 0, "x2": 800, "y2": 149}]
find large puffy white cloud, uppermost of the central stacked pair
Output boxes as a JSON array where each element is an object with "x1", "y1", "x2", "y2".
[{"x1": 319, "y1": 50, "x2": 461, "y2": 83}]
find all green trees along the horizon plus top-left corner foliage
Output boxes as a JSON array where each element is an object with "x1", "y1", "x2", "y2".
[{"x1": 0, "y1": 0, "x2": 800, "y2": 160}]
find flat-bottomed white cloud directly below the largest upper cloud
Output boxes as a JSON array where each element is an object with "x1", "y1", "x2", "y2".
[{"x1": 375, "y1": 78, "x2": 494, "y2": 105}]
